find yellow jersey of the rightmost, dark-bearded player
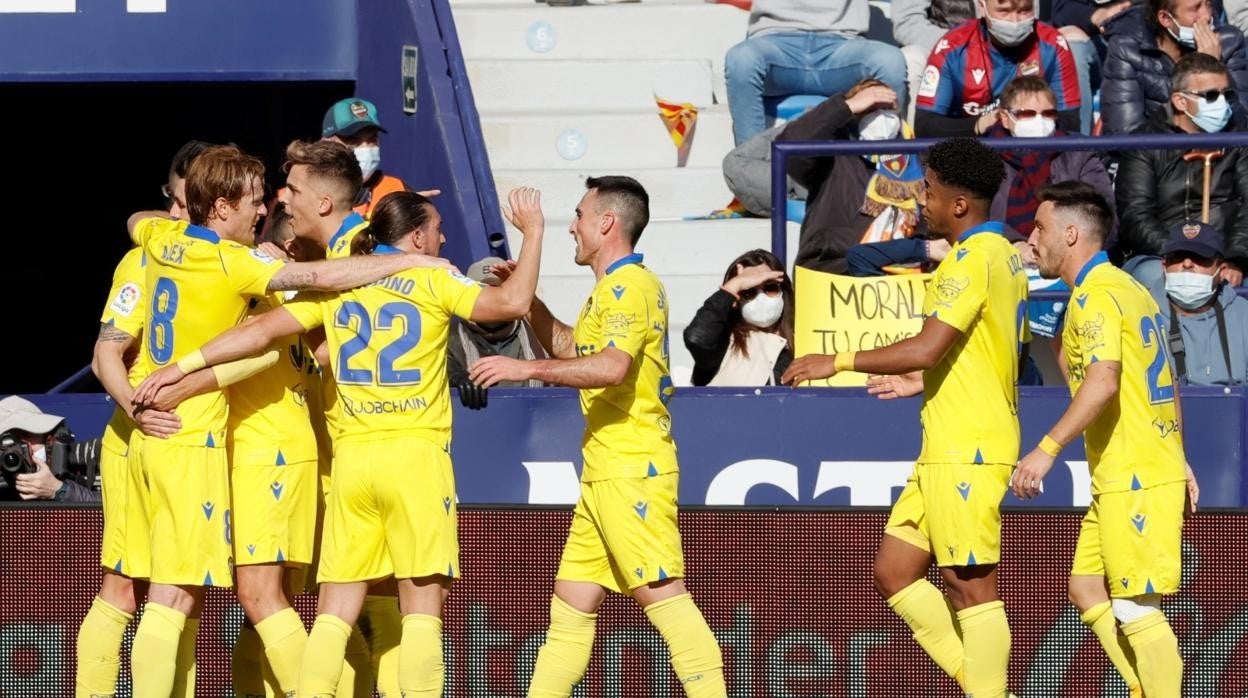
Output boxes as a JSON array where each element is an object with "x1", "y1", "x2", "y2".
[{"x1": 1062, "y1": 252, "x2": 1187, "y2": 494}]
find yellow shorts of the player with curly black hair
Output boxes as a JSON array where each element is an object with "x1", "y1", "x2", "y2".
[{"x1": 884, "y1": 463, "x2": 1013, "y2": 567}]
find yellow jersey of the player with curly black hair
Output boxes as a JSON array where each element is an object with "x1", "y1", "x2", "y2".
[{"x1": 919, "y1": 222, "x2": 1031, "y2": 466}]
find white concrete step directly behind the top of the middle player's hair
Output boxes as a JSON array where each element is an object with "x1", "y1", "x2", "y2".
[{"x1": 494, "y1": 167, "x2": 733, "y2": 219}]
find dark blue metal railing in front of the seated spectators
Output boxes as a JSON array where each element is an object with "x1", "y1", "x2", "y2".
[{"x1": 771, "y1": 134, "x2": 1248, "y2": 260}]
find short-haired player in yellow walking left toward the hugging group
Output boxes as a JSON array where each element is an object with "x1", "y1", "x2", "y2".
[{"x1": 469, "y1": 176, "x2": 728, "y2": 698}]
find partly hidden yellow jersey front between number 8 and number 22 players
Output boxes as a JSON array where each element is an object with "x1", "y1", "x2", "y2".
[{"x1": 227, "y1": 293, "x2": 319, "y2": 466}]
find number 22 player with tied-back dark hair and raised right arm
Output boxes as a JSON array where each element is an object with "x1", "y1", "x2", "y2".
[{"x1": 136, "y1": 190, "x2": 545, "y2": 697}]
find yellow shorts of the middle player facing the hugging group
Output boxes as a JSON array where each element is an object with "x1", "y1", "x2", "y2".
[{"x1": 555, "y1": 473, "x2": 685, "y2": 593}]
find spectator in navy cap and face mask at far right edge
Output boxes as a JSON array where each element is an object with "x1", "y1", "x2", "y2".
[{"x1": 1149, "y1": 221, "x2": 1248, "y2": 386}]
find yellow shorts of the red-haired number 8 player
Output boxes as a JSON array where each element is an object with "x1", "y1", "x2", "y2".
[{"x1": 140, "y1": 438, "x2": 233, "y2": 587}]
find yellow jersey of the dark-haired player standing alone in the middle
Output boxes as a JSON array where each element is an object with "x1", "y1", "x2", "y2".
[{"x1": 573, "y1": 255, "x2": 679, "y2": 482}]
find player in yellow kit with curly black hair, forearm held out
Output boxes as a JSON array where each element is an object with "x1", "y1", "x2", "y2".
[{"x1": 782, "y1": 139, "x2": 1030, "y2": 698}]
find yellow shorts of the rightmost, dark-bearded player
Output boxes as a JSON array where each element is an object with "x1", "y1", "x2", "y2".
[{"x1": 1071, "y1": 482, "x2": 1187, "y2": 598}]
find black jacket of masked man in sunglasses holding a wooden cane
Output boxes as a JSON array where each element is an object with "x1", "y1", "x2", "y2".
[{"x1": 1114, "y1": 109, "x2": 1248, "y2": 268}]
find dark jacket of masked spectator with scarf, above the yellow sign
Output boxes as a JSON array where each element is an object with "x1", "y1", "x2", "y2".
[{"x1": 776, "y1": 95, "x2": 928, "y2": 273}]
